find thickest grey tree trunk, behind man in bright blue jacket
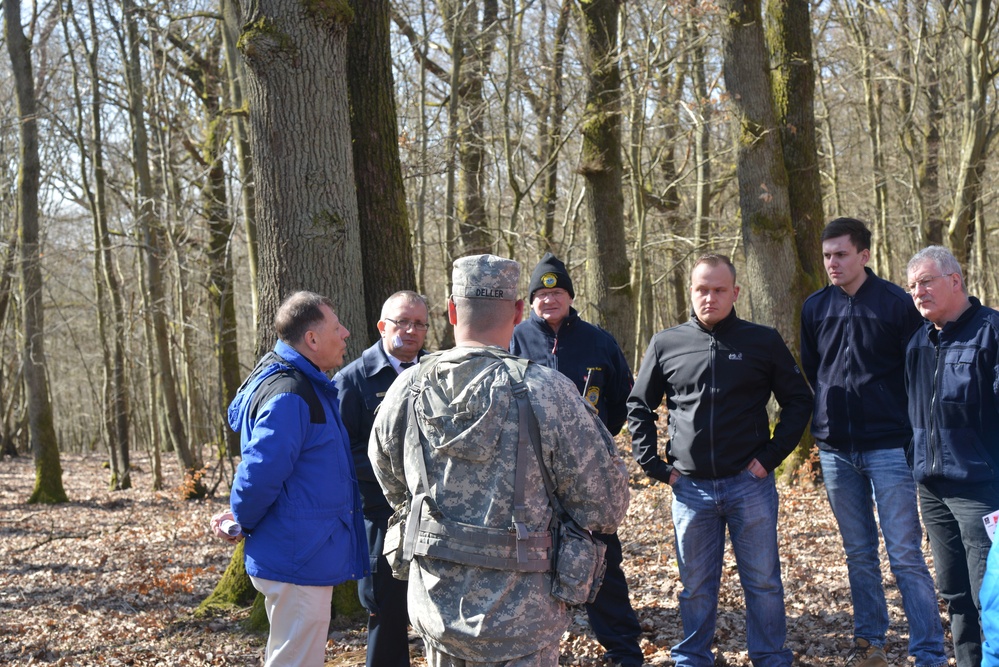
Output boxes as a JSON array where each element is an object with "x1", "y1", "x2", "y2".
[{"x1": 231, "y1": 0, "x2": 365, "y2": 355}]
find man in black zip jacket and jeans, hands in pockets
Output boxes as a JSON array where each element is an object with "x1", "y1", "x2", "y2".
[{"x1": 628, "y1": 255, "x2": 812, "y2": 667}]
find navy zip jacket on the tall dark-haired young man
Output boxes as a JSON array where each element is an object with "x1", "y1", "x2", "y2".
[{"x1": 801, "y1": 268, "x2": 923, "y2": 452}]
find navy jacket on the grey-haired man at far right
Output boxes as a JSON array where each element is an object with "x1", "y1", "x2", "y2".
[{"x1": 905, "y1": 297, "x2": 999, "y2": 484}]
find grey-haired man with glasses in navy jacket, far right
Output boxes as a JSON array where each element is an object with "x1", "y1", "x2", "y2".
[{"x1": 905, "y1": 246, "x2": 999, "y2": 667}]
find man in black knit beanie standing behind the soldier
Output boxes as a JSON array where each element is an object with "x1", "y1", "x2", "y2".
[{"x1": 510, "y1": 252, "x2": 643, "y2": 667}]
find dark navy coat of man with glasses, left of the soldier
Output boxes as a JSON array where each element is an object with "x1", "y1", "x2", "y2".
[{"x1": 333, "y1": 340, "x2": 425, "y2": 520}]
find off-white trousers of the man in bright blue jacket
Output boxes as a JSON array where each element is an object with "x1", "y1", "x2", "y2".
[{"x1": 250, "y1": 577, "x2": 333, "y2": 667}]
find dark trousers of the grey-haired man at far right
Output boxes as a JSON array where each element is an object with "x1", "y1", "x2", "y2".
[{"x1": 919, "y1": 480, "x2": 999, "y2": 667}]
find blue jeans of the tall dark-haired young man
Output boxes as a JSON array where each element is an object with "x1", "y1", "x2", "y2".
[{"x1": 819, "y1": 448, "x2": 947, "y2": 667}]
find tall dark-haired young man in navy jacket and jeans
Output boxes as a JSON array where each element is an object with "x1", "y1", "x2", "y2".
[{"x1": 801, "y1": 218, "x2": 947, "y2": 667}]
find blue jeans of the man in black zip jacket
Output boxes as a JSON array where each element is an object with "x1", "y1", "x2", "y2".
[{"x1": 672, "y1": 470, "x2": 793, "y2": 667}]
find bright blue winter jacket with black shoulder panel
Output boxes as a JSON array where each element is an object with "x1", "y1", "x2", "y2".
[{"x1": 229, "y1": 341, "x2": 368, "y2": 586}]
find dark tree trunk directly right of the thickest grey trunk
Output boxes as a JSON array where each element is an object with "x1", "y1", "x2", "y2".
[{"x1": 347, "y1": 0, "x2": 416, "y2": 344}]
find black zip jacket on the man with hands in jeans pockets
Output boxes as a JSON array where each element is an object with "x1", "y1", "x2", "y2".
[{"x1": 628, "y1": 309, "x2": 812, "y2": 483}]
